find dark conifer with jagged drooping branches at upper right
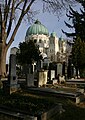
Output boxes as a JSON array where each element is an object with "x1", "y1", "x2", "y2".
[{"x1": 62, "y1": 0, "x2": 85, "y2": 41}]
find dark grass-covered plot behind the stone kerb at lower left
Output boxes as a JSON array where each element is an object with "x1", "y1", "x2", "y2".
[{"x1": 0, "y1": 89, "x2": 55, "y2": 115}]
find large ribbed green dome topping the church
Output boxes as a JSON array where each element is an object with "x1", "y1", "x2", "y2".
[{"x1": 26, "y1": 20, "x2": 49, "y2": 36}]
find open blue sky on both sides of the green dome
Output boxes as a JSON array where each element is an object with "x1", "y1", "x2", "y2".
[{"x1": 7, "y1": 2, "x2": 80, "y2": 63}]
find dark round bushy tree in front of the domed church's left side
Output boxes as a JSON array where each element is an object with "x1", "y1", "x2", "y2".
[{"x1": 17, "y1": 40, "x2": 42, "y2": 65}]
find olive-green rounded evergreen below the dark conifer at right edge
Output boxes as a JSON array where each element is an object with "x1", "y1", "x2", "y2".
[{"x1": 72, "y1": 37, "x2": 85, "y2": 77}]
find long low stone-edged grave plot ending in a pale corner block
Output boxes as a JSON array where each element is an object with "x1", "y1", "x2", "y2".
[{"x1": 28, "y1": 88, "x2": 84, "y2": 104}]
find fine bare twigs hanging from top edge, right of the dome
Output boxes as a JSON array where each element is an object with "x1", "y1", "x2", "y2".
[{"x1": 42, "y1": 0, "x2": 76, "y2": 14}]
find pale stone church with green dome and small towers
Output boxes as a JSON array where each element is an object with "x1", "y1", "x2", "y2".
[{"x1": 25, "y1": 20, "x2": 70, "y2": 62}]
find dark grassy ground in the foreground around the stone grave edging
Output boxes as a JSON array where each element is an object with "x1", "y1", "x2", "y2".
[{"x1": 0, "y1": 86, "x2": 85, "y2": 120}]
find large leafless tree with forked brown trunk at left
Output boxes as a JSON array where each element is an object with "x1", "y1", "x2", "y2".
[{"x1": 0, "y1": 0, "x2": 75, "y2": 76}]
